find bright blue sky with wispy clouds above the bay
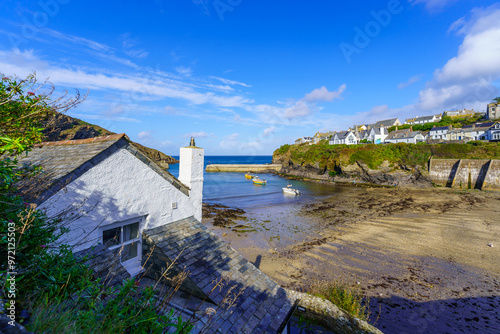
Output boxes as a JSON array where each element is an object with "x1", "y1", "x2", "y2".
[{"x1": 0, "y1": 0, "x2": 500, "y2": 155}]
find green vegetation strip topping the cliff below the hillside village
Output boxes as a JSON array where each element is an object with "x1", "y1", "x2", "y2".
[{"x1": 273, "y1": 142, "x2": 500, "y2": 171}]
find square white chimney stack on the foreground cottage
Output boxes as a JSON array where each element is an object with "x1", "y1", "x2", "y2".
[{"x1": 179, "y1": 137, "x2": 205, "y2": 222}]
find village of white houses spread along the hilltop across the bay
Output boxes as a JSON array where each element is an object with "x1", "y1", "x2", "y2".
[{"x1": 295, "y1": 98, "x2": 500, "y2": 145}]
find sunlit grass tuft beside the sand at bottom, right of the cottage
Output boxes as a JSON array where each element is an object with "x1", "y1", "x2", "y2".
[{"x1": 309, "y1": 281, "x2": 370, "y2": 321}]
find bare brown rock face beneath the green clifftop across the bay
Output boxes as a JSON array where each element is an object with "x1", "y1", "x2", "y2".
[{"x1": 273, "y1": 158, "x2": 431, "y2": 186}]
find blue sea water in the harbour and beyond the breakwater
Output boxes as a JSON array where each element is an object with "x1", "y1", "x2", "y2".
[{"x1": 169, "y1": 155, "x2": 341, "y2": 209}]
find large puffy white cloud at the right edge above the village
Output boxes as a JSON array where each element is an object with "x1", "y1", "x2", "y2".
[{"x1": 417, "y1": 6, "x2": 500, "y2": 111}]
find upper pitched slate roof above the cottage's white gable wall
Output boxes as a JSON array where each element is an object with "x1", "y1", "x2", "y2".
[{"x1": 17, "y1": 133, "x2": 189, "y2": 204}]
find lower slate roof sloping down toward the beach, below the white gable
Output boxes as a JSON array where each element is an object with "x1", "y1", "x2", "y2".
[{"x1": 143, "y1": 217, "x2": 297, "y2": 333}]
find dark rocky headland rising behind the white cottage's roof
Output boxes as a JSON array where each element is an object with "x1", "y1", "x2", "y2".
[{"x1": 43, "y1": 112, "x2": 179, "y2": 169}]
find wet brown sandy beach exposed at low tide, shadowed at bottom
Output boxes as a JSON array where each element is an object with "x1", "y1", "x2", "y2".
[{"x1": 204, "y1": 187, "x2": 500, "y2": 333}]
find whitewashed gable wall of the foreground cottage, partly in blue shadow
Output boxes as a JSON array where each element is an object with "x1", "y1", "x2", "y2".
[{"x1": 40, "y1": 149, "x2": 203, "y2": 252}]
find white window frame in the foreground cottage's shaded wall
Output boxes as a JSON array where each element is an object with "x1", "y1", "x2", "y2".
[{"x1": 99, "y1": 216, "x2": 146, "y2": 276}]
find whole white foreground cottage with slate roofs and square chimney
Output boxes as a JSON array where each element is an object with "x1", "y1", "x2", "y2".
[{"x1": 19, "y1": 134, "x2": 297, "y2": 333}]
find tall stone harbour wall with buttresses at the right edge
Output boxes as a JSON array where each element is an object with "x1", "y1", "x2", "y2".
[{"x1": 429, "y1": 159, "x2": 500, "y2": 190}]
